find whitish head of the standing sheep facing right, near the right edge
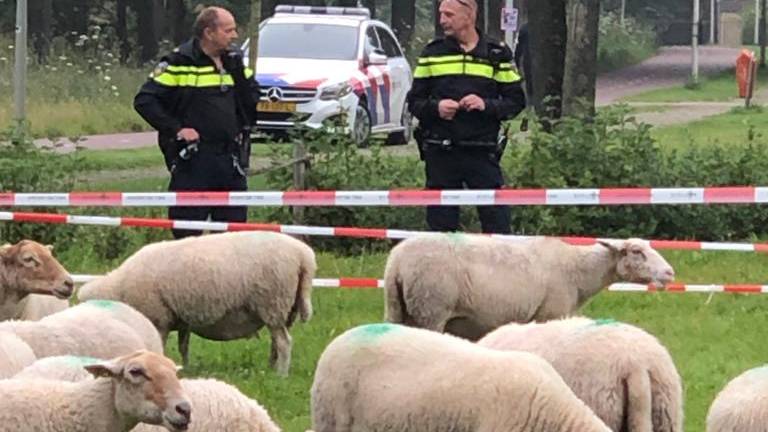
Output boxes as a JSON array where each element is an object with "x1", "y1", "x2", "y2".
[{"x1": 599, "y1": 238, "x2": 675, "y2": 288}]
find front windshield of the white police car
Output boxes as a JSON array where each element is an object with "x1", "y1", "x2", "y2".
[{"x1": 259, "y1": 23, "x2": 357, "y2": 60}]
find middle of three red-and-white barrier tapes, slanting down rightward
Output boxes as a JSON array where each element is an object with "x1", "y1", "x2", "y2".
[{"x1": 6, "y1": 212, "x2": 768, "y2": 252}]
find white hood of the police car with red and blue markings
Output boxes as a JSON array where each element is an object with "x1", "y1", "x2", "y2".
[{"x1": 256, "y1": 57, "x2": 359, "y2": 89}]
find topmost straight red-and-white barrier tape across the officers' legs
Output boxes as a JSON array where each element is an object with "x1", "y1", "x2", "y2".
[{"x1": 0, "y1": 186, "x2": 768, "y2": 207}]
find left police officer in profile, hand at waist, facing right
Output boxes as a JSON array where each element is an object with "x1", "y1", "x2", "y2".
[{"x1": 134, "y1": 7, "x2": 259, "y2": 238}]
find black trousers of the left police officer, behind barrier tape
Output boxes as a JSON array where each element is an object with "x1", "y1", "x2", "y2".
[{"x1": 168, "y1": 150, "x2": 248, "y2": 239}]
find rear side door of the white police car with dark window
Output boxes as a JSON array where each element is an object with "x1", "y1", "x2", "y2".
[{"x1": 376, "y1": 25, "x2": 412, "y2": 126}]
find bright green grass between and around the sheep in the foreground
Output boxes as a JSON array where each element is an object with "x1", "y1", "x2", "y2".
[{"x1": 60, "y1": 248, "x2": 768, "y2": 432}]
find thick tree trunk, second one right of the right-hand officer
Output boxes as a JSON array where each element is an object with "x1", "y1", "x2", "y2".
[{"x1": 563, "y1": 0, "x2": 600, "y2": 117}]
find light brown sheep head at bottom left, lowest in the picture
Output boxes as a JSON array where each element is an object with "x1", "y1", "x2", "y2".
[{"x1": 85, "y1": 350, "x2": 192, "y2": 431}]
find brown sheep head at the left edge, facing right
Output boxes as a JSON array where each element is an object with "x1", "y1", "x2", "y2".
[{"x1": 0, "y1": 240, "x2": 75, "y2": 299}]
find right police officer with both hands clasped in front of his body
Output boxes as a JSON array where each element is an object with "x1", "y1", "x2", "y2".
[{"x1": 408, "y1": 0, "x2": 525, "y2": 233}]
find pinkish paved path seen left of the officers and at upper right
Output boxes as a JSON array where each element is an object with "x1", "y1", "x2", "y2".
[{"x1": 36, "y1": 47, "x2": 739, "y2": 151}]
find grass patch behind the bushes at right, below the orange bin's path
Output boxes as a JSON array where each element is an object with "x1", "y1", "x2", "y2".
[{"x1": 652, "y1": 108, "x2": 768, "y2": 148}]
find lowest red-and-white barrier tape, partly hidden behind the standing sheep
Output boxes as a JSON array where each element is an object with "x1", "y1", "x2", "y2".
[{"x1": 72, "y1": 275, "x2": 768, "y2": 294}]
